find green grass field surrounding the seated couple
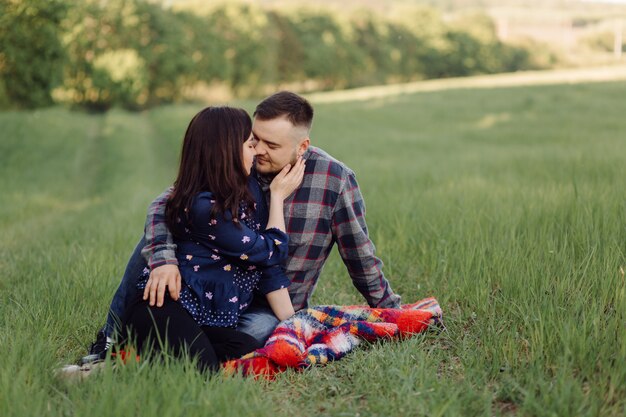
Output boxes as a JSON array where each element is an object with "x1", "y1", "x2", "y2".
[{"x1": 0, "y1": 82, "x2": 626, "y2": 417}]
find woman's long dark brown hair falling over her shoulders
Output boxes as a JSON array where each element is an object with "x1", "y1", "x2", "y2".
[{"x1": 165, "y1": 107, "x2": 254, "y2": 233}]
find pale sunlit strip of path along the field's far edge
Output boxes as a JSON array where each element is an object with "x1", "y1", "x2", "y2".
[{"x1": 307, "y1": 65, "x2": 626, "y2": 103}]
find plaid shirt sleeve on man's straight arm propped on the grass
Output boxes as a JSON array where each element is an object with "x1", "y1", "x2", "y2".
[{"x1": 332, "y1": 173, "x2": 400, "y2": 308}]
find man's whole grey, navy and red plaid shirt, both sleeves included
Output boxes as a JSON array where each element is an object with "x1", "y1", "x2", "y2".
[{"x1": 142, "y1": 146, "x2": 400, "y2": 311}]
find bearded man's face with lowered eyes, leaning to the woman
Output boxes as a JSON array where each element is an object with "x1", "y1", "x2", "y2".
[{"x1": 252, "y1": 117, "x2": 309, "y2": 175}]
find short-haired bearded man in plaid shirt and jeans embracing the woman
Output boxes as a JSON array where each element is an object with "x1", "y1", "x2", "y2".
[{"x1": 82, "y1": 91, "x2": 400, "y2": 363}]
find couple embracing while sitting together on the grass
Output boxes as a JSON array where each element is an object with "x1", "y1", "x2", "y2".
[{"x1": 81, "y1": 92, "x2": 400, "y2": 370}]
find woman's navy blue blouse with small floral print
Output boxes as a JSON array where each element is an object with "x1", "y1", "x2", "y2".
[{"x1": 139, "y1": 180, "x2": 290, "y2": 327}]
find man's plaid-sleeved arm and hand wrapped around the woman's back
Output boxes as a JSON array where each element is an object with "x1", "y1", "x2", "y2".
[{"x1": 141, "y1": 187, "x2": 181, "y2": 307}]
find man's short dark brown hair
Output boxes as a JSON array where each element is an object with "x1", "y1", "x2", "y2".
[{"x1": 254, "y1": 91, "x2": 313, "y2": 129}]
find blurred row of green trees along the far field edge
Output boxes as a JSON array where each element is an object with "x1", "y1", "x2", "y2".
[{"x1": 0, "y1": 0, "x2": 540, "y2": 110}]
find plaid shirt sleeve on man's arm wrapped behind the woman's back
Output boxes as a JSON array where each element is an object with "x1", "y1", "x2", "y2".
[{"x1": 141, "y1": 187, "x2": 178, "y2": 269}]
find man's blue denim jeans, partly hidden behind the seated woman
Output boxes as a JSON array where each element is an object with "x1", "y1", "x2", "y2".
[{"x1": 102, "y1": 237, "x2": 278, "y2": 348}]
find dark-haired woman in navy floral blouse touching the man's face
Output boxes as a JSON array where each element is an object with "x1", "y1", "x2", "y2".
[{"x1": 124, "y1": 107, "x2": 304, "y2": 370}]
